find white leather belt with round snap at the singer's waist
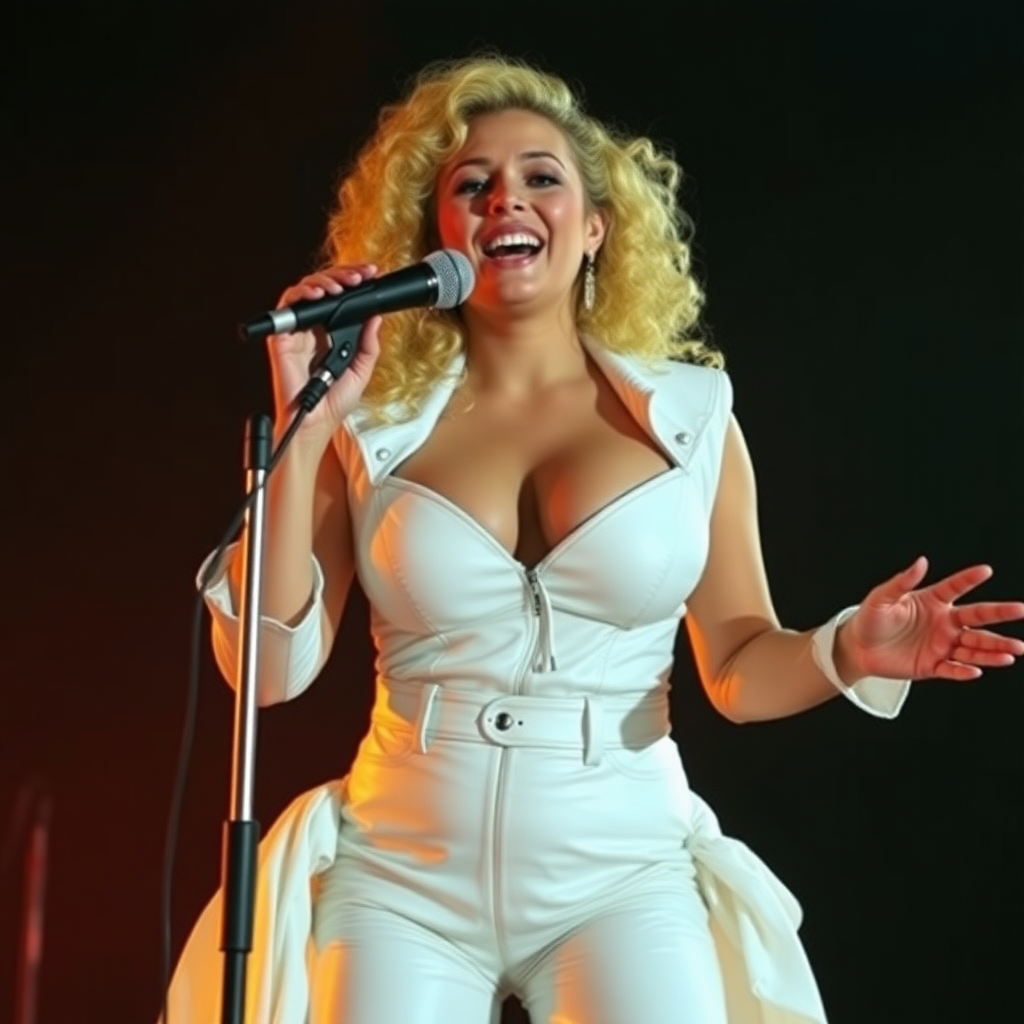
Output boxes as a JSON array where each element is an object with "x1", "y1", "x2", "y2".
[{"x1": 372, "y1": 682, "x2": 669, "y2": 765}]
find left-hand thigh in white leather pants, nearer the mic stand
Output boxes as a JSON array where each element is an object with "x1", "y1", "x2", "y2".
[{"x1": 309, "y1": 907, "x2": 500, "y2": 1024}]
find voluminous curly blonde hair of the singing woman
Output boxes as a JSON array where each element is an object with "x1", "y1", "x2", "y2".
[{"x1": 325, "y1": 54, "x2": 723, "y2": 414}]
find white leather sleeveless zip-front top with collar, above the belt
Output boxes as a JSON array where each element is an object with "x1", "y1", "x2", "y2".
[{"x1": 336, "y1": 342, "x2": 732, "y2": 696}]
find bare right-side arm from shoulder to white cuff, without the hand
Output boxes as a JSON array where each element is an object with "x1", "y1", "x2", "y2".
[{"x1": 686, "y1": 418, "x2": 845, "y2": 722}]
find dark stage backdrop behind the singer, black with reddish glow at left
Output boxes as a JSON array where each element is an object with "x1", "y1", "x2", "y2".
[{"x1": 0, "y1": 0, "x2": 1024, "y2": 1024}]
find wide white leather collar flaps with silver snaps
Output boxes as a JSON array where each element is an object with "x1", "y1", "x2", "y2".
[{"x1": 345, "y1": 336, "x2": 725, "y2": 485}]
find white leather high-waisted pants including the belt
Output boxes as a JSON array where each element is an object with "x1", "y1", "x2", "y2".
[{"x1": 311, "y1": 686, "x2": 726, "y2": 1024}]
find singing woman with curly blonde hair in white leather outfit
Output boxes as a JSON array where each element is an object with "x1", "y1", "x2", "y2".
[{"x1": 171, "y1": 58, "x2": 1024, "y2": 1024}]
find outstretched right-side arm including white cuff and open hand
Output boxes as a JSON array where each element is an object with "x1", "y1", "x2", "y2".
[{"x1": 687, "y1": 411, "x2": 1024, "y2": 722}]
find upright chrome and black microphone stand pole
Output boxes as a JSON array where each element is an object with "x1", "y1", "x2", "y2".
[{"x1": 220, "y1": 415, "x2": 272, "y2": 1024}]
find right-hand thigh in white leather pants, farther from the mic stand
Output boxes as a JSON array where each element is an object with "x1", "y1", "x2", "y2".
[{"x1": 522, "y1": 890, "x2": 726, "y2": 1024}]
